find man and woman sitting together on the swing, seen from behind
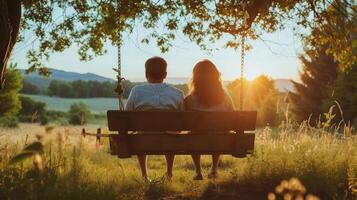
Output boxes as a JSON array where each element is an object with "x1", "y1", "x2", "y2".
[{"x1": 125, "y1": 57, "x2": 234, "y2": 180}]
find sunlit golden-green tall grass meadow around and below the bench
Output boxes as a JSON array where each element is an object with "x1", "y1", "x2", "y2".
[{"x1": 0, "y1": 124, "x2": 357, "y2": 200}]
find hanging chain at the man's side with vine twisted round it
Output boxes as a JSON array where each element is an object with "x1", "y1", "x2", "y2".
[{"x1": 113, "y1": 0, "x2": 125, "y2": 110}]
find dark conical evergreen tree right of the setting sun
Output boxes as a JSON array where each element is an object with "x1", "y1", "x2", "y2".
[{"x1": 289, "y1": 47, "x2": 338, "y2": 124}]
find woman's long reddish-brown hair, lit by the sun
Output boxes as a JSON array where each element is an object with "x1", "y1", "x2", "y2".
[{"x1": 189, "y1": 60, "x2": 225, "y2": 106}]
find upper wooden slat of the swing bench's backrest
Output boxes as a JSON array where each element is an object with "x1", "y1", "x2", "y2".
[{"x1": 107, "y1": 111, "x2": 257, "y2": 132}]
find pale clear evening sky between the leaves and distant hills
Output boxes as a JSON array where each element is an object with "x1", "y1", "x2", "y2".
[{"x1": 10, "y1": 21, "x2": 302, "y2": 80}]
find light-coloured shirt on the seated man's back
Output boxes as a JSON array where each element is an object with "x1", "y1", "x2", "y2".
[{"x1": 125, "y1": 83, "x2": 184, "y2": 111}]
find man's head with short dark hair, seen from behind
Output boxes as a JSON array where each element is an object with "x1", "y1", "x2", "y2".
[{"x1": 145, "y1": 57, "x2": 167, "y2": 83}]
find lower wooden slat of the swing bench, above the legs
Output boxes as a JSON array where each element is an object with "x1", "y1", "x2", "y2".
[{"x1": 110, "y1": 133, "x2": 255, "y2": 157}]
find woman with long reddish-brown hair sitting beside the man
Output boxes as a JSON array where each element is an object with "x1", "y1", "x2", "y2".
[{"x1": 185, "y1": 60, "x2": 234, "y2": 180}]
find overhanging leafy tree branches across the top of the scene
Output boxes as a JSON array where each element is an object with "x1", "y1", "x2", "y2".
[{"x1": 21, "y1": 0, "x2": 356, "y2": 74}]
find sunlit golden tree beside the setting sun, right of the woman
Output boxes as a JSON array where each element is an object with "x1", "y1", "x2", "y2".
[{"x1": 228, "y1": 75, "x2": 279, "y2": 126}]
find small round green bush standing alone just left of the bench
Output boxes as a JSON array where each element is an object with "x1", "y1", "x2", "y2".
[{"x1": 68, "y1": 102, "x2": 91, "y2": 125}]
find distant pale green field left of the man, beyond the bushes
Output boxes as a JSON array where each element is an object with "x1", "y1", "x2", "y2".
[{"x1": 24, "y1": 95, "x2": 122, "y2": 113}]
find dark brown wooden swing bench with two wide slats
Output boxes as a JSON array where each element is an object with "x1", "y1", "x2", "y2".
[{"x1": 107, "y1": 111, "x2": 257, "y2": 158}]
